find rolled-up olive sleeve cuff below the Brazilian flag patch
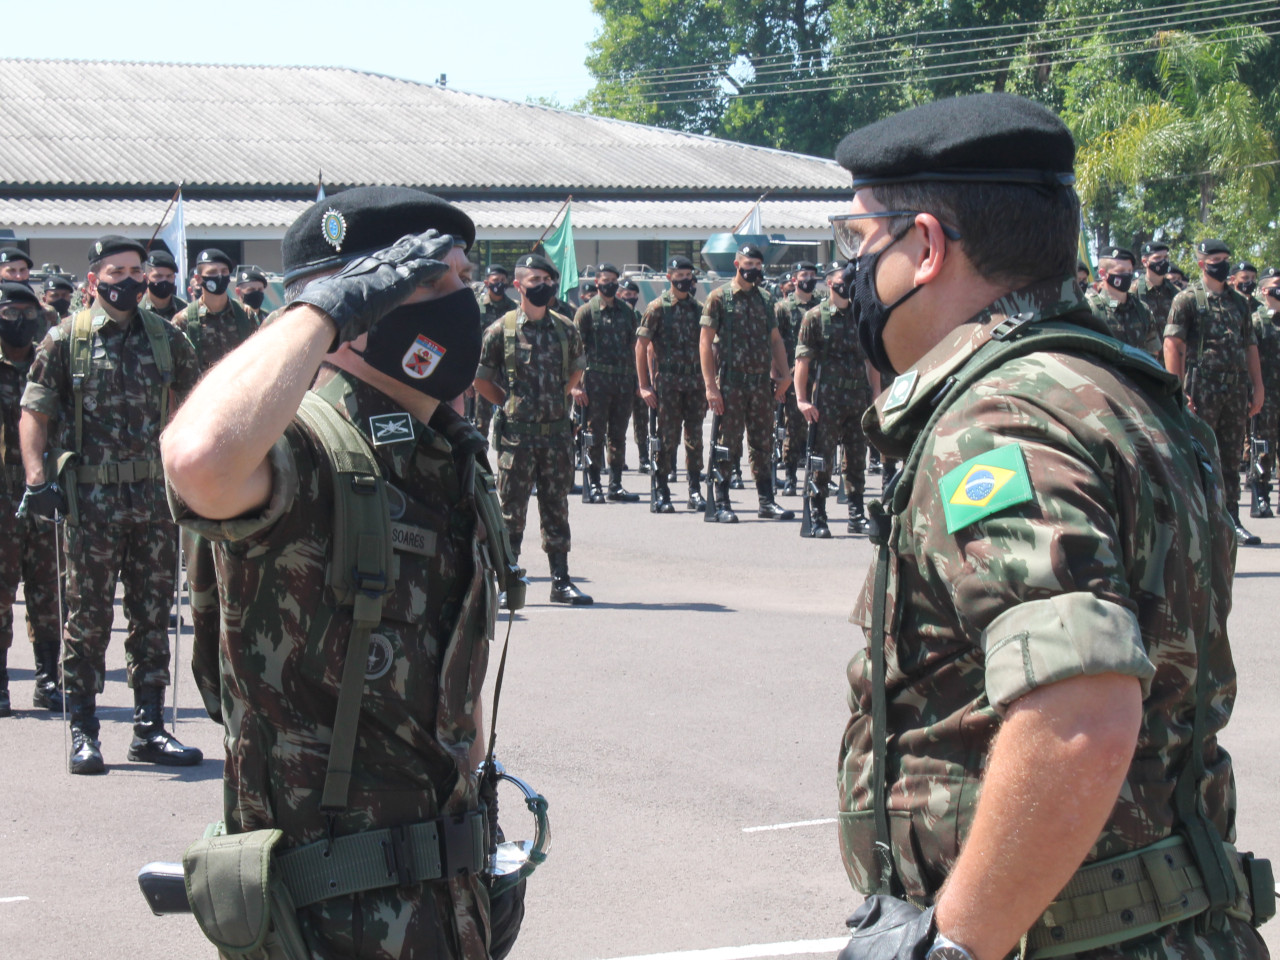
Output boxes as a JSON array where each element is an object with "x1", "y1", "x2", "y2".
[{"x1": 982, "y1": 593, "x2": 1156, "y2": 716}]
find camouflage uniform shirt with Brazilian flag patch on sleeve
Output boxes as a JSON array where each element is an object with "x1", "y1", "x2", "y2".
[{"x1": 840, "y1": 276, "x2": 1261, "y2": 957}]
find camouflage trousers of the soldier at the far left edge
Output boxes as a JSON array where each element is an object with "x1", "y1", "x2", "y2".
[{"x1": 0, "y1": 492, "x2": 61, "y2": 650}]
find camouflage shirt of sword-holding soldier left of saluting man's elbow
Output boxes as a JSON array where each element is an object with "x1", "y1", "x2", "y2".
[{"x1": 22, "y1": 306, "x2": 200, "y2": 525}]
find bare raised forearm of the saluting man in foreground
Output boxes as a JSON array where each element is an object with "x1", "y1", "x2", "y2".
[{"x1": 160, "y1": 305, "x2": 334, "y2": 520}]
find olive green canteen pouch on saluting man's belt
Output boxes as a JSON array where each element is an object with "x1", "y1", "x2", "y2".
[{"x1": 182, "y1": 829, "x2": 311, "y2": 960}]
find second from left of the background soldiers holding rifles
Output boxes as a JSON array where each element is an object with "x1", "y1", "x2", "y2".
[{"x1": 635, "y1": 256, "x2": 707, "y2": 513}]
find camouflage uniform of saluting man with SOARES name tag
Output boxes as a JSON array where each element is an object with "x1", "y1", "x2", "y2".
[{"x1": 173, "y1": 366, "x2": 497, "y2": 960}]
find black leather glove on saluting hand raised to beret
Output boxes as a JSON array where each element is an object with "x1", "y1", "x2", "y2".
[{"x1": 293, "y1": 230, "x2": 453, "y2": 348}]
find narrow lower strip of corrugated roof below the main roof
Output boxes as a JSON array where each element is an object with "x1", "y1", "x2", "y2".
[{"x1": 0, "y1": 197, "x2": 838, "y2": 236}]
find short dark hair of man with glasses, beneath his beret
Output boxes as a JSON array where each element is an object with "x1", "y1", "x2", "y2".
[{"x1": 872, "y1": 180, "x2": 1080, "y2": 287}]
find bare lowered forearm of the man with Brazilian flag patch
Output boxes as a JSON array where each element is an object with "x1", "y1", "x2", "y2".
[{"x1": 937, "y1": 673, "x2": 1142, "y2": 960}]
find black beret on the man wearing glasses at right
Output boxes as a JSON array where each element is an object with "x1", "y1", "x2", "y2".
[{"x1": 836, "y1": 93, "x2": 1075, "y2": 191}]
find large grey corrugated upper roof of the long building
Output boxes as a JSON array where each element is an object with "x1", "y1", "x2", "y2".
[{"x1": 0, "y1": 59, "x2": 849, "y2": 193}]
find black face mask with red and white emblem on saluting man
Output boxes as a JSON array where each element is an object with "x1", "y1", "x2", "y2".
[{"x1": 361, "y1": 289, "x2": 481, "y2": 402}]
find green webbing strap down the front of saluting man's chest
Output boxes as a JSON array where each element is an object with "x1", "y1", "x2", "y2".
[{"x1": 297, "y1": 392, "x2": 398, "y2": 815}]
